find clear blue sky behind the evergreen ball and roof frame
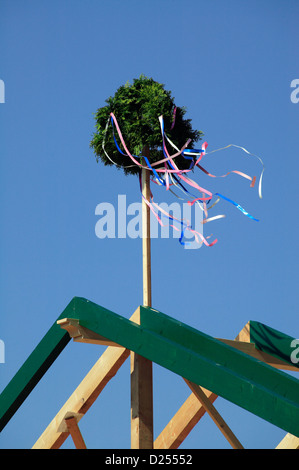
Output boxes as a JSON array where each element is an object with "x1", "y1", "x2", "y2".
[{"x1": 0, "y1": 0, "x2": 299, "y2": 449}]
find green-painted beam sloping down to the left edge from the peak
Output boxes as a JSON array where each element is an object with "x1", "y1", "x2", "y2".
[{"x1": 0, "y1": 300, "x2": 74, "y2": 431}]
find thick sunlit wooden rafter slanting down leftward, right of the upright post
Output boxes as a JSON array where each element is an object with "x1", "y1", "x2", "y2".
[{"x1": 154, "y1": 389, "x2": 218, "y2": 449}]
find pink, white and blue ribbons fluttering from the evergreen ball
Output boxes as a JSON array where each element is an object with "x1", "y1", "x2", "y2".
[{"x1": 102, "y1": 112, "x2": 265, "y2": 246}]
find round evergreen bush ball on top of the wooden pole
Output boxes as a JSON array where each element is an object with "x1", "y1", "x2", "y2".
[{"x1": 90, "y1": 75, "x2": 203, "y2": 174}]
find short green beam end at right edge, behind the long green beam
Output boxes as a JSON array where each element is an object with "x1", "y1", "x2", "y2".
[{"x1": 249, "y1": 320, "x2": 299, "y2": 369}]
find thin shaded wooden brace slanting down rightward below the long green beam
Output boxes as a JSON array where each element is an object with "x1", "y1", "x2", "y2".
[{"x1": 184, "y1": 379, "x2": 243, "y2": 449}]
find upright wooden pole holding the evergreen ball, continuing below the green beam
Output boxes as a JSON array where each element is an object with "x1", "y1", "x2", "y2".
[{"x1": 131, "y1": 147, "x2": 154, "y2": 449}]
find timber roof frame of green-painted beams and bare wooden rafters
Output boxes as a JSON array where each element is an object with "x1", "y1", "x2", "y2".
[{"x1": 0, "y1": 298, "x2": 299, "y2": 449}]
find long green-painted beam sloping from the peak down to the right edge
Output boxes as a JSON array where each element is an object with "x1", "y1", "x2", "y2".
[{"x1": 68, "y1": 298, "x2": 299, "y2": 437}]
